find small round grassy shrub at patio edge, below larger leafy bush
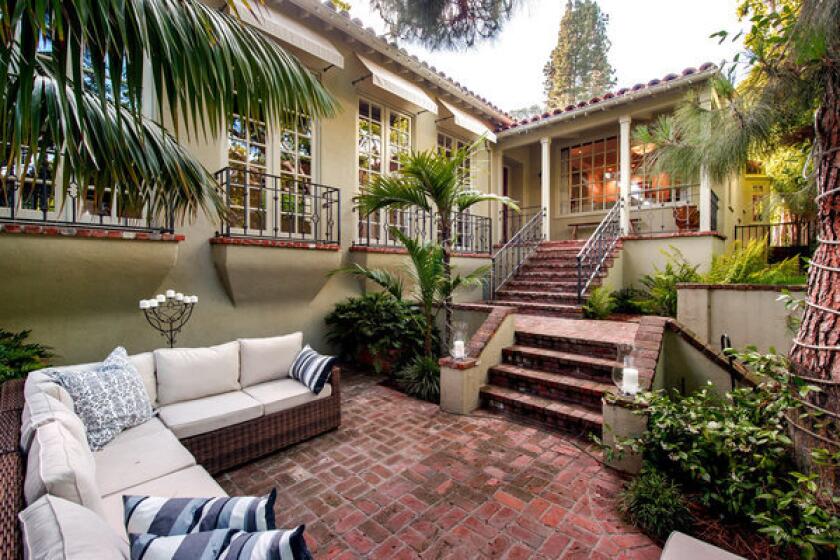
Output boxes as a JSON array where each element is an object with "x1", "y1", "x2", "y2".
[{"x1": 619, "y1": 465, "x2": 692, "y2": 541}]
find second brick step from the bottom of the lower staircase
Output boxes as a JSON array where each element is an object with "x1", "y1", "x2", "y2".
[{"x1": 488, "y1": 364, "x2": 615, "y2": 413}]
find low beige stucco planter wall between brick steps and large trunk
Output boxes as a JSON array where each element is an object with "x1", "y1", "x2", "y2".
[{"x1": 677, "y1": 284, "x2": 803, "y2": 353}]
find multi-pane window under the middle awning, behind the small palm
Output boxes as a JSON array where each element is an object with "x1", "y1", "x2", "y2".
[{"x1": 358, "y1": 99, "x2": 412, "y2": 242}]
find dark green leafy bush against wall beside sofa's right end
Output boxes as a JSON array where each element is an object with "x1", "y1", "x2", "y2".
[{"x1": 325, "y1": 292, "x2": 436, "y2": 371}]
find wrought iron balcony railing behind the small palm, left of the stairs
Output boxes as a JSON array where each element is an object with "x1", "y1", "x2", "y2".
[{"x1": 354, "y1": 208, "x2": 493, "y2": 255}]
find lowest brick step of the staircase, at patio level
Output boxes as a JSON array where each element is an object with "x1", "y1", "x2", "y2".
[{"x1": 479, "y1": 385, "x2": 604, "y2": 436}]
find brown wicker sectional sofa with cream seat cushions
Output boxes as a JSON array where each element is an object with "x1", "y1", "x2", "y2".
[{"x1": 0, "y1": 333, "x2": 341, "y2": 558}]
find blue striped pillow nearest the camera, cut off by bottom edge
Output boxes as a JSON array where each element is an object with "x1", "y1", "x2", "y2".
[{"x1": 129, "y1": 525, "x2": 312, "y2": 560}]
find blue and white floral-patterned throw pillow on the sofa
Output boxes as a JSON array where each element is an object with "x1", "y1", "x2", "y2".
[{"x1": 48, "y1": 346, "x2": 152, "y2": 451}]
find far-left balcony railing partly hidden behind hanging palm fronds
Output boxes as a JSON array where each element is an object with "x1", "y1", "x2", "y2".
[{"x1": 0, "y1": 175, "x2": 175, "y2": 233}]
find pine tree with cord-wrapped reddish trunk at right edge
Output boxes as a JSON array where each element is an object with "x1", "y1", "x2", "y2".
[{"x1": 638, "y1": 0, "x2": 840, "y2": 488}]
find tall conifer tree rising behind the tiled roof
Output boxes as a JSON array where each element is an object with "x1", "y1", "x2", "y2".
[{"x1": 543, "y1": 0, "x2": 615, "y2": 110}]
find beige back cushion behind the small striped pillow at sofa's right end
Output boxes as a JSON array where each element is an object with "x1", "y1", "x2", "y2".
[{"x1": 239, "y1": 332, "x2": 303, "y2": 387}]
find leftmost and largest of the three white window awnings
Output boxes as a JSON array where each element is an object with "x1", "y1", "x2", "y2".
[{"x1": 237, "y1": 2, "x2": 344, "y2": 68}]
